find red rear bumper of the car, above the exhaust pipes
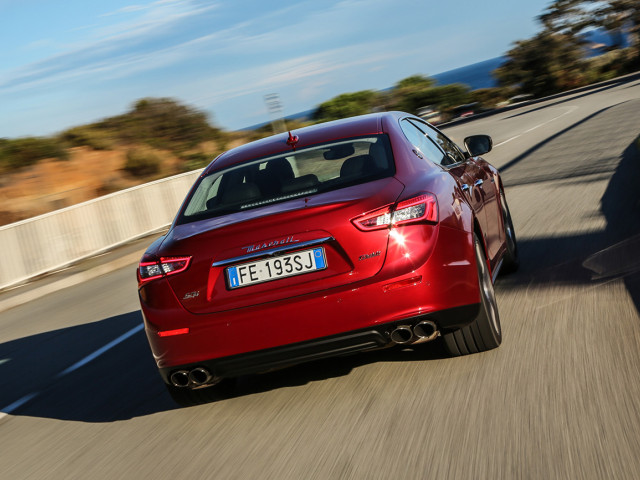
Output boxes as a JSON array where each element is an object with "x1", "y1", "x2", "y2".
[{"x1": 140, "y1": 228, "x2": 480, "y2": 379}]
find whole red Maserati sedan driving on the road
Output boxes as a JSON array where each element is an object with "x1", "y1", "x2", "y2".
[{"x1": 138, "y1": 112, "x2": 518, "y2": 404}]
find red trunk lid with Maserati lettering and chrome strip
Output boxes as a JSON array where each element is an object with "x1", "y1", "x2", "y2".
[{"x1": 161, "y1": 177, "x2": 404, "y2": 313}]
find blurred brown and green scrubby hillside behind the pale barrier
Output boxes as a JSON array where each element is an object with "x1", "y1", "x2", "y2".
[{"x1": 0, "y1": 98, "x2": 236, "y2": 225}]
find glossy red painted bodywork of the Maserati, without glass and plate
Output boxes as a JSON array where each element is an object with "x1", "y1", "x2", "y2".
[{"x1": 138, "y1": 112, "x2": 507, "y2": 387}]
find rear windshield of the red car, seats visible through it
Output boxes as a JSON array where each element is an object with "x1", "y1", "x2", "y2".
[{"x1": 178, "y1": 135, "x2": 395, "y2": 224}]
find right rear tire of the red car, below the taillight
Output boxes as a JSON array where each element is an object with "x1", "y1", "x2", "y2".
[{"x1": 442, "y1": 234, "x2": 502, "y2": 357}]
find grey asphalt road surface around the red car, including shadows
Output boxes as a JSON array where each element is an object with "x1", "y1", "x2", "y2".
[{"x1": 0, "y1": 80, "x2": 640, "y2": 480}]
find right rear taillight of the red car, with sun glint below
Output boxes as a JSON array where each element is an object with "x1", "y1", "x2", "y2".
[{"x1": 352, "y1": 193, "x2": 438, "y2": 231}]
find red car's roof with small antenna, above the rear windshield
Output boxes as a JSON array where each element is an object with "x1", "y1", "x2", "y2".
[{"x1": 204, "y1": 112, "x2": 407, "y2": 175}]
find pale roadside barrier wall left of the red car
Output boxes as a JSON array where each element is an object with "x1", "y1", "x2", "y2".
[{"x1": 0, "y1": 170, "x2": 201, "y2": 290}]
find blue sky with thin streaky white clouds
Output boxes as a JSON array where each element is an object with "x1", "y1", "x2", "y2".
[{"x1": 0, "y1": 0, "x2": 550, "y2": 138}]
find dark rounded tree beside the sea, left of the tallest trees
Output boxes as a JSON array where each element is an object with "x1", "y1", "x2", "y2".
[{"x1": 494, "y1": 30, "x2": 585, "y2": 97}]
